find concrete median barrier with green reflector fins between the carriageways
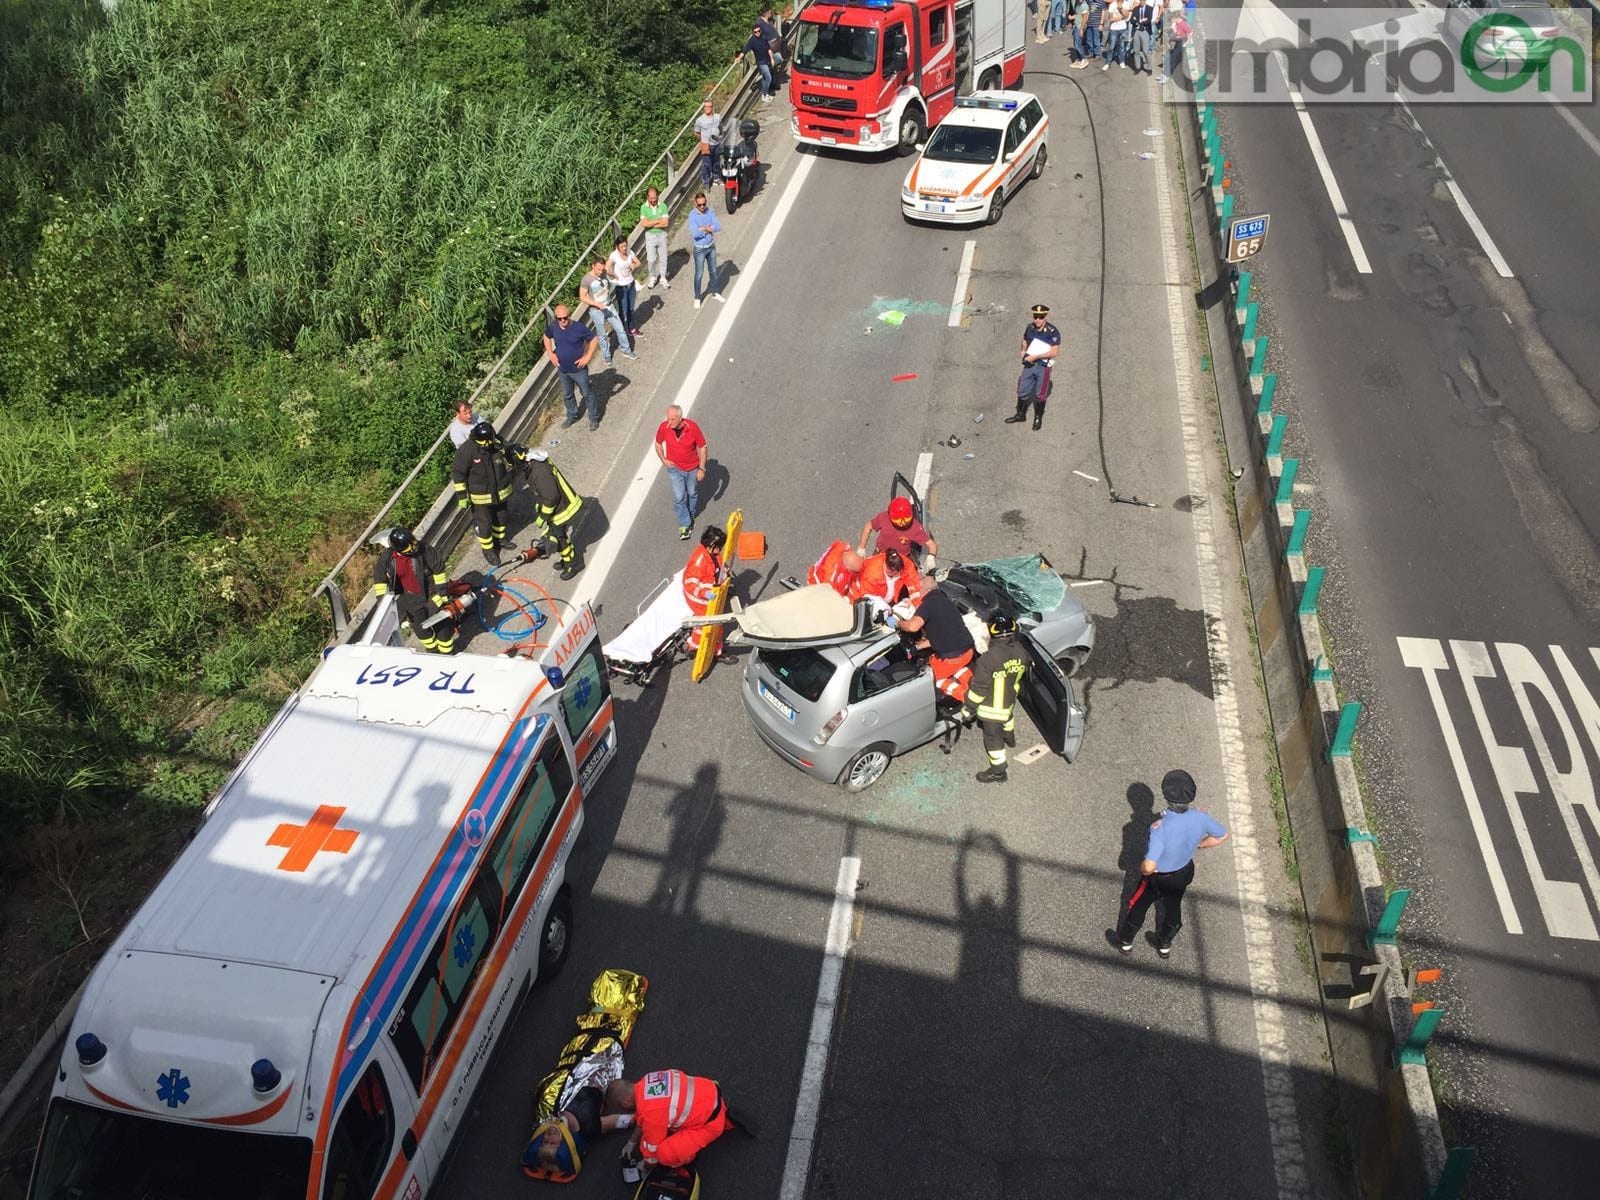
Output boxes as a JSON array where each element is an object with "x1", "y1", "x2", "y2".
[{"x1": 1178, "y1": 21, "x2": 1472, "y2": 1200}]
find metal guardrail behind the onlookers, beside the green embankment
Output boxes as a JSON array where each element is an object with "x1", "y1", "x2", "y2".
[{"x1": 312, "y1": 47, "x2": 774, "y2": 645}]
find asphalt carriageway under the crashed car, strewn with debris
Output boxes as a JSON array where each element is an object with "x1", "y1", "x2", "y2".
[{"x1": 425, "y1": 54, "x2": 1338, "y2": 1200}]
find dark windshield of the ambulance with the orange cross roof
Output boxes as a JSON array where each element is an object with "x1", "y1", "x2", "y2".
[{"x1": 29, "y1": 1099, "x2": 310, "y2": 1200}]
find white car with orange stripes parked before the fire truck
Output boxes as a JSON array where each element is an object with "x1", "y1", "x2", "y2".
[{"x1": 901, "y1": 91, "x2": 1050, "y2": 226}]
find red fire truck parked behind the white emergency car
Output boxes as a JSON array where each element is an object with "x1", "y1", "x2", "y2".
[{"x1": 789, "y1": 0, "x2": 1027, "y2": 154}]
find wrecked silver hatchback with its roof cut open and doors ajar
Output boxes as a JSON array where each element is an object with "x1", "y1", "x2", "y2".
[{"x1": 739, "y1": 555, "x2": 1094, "y2": 792}]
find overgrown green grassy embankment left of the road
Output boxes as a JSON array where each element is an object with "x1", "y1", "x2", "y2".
[{"x1": 0, "y1": 0, "x2": 755, "y2": 1100}]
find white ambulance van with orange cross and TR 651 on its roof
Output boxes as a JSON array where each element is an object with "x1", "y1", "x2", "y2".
[{"x1": 29, "y1": 606, "x2": 618, "y2": 1200}]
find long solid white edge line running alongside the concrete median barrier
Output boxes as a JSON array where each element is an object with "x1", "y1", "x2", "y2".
[{"x1": 1150, "y1": 98, "x2": 1312, "y2": 1197}]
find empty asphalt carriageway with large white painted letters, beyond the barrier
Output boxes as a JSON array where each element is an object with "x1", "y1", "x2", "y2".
[{"x1": 1221, "y1": 6, "x2": 1600, "y2": 1195}]
